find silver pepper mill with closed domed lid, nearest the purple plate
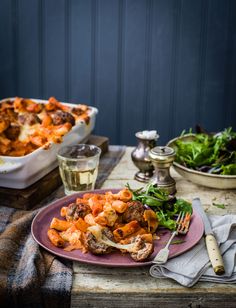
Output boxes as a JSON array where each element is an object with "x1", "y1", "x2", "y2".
[{"x1": 148, "y1": 146, "x2": 176, "y2": 195}]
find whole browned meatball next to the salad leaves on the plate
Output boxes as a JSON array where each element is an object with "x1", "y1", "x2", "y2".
[{"x1": 123, "y1": 201, "x2": 146, "y2": 226}]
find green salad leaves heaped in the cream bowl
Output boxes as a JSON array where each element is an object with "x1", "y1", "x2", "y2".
[{"x1": 175, "y1": 127, "x2": 236, "y2": 175}]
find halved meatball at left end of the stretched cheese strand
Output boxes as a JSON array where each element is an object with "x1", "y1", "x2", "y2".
[{"x1": 85, "y1": 228, "x2": 114, "y2": 255}]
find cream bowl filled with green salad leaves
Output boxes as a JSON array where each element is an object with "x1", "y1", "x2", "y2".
[{"x1": 167, "y1": 128, "x2": 236, "y2": 189}]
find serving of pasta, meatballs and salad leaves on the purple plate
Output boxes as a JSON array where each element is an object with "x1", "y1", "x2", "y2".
[{"x1": 47, "y1": 185, "x2": 192, "y2": 262}]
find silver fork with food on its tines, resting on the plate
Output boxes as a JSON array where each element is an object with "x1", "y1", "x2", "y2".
[{"x1": 152, "y1": 212, "x2": 191, "y2": 264}]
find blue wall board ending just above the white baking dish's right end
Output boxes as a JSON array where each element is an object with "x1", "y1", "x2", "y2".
[{"x1": 69, "y1": 0, "x2": 92, "y2": 104}]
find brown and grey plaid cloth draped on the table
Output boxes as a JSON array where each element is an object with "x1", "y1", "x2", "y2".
[{"x1": 0, "y1": 146, "x2": 125, "y2": 308}]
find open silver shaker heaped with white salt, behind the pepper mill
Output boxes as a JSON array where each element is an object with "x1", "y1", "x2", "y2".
[{"x1": 131, "y1": 130, "x2": 159, "y2": 182}]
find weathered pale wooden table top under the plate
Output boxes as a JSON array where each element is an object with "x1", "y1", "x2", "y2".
[{"x1": 71, "y1": 147, "x2": 236, "y2": 308}]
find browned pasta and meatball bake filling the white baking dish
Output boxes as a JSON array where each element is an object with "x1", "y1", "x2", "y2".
[{"x1": 0, "y1": 97, "x2": 90, "y2": 157}]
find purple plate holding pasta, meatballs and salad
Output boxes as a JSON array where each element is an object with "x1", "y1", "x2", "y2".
[{"x1": 31, "y1": 189, "x2": 204, "y2": 267}]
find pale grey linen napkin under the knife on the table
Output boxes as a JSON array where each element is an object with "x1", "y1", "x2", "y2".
[{"x1": 150, "y1": 215, "x2": 236, "y2": 287}]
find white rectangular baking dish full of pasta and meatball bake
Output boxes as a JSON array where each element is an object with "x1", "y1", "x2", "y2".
[{"x1": 0, "y1": 97, "x2": 98, "y2": 189}]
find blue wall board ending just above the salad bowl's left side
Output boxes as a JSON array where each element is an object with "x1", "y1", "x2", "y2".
[{"x1": 171, "y1": 0, "x2": 202, "y2": 136}]
